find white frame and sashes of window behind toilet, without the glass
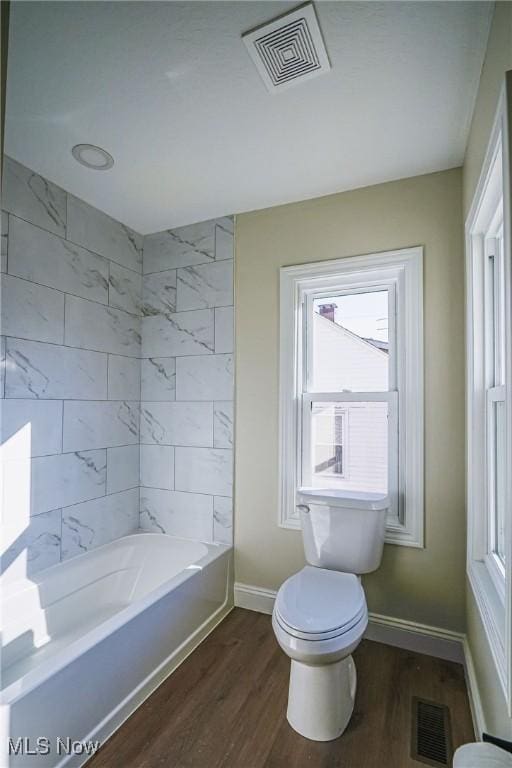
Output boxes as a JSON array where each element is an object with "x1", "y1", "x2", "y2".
[{"x1": 278, "y1": 246, "x2": 424, "y2": 548}]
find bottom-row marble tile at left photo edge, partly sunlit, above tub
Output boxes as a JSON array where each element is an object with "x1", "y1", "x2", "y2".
[{"x1": 1, "y1": 509, "x2": 62, "y2": 580}]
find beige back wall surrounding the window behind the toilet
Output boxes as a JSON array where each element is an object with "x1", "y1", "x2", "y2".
[{"x1": 235, "y1": 169, "x2": 465, "y2": 630}]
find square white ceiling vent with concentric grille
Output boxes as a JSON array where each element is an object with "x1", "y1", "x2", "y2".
[{"x1": 242, "y1": 3, "x2": 331, "y2": 93}]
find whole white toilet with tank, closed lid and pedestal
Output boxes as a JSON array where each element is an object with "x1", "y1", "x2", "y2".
[{"x1": 272, "y1": 489, "x2": 389, "y2": 741}]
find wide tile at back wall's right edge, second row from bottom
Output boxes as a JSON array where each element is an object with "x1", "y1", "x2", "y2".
[{"x1": 174, "y1": 448, "x2": 233, "y2": 496}]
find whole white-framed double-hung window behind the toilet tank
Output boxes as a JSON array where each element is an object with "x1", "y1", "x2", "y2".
[{"x1": 280, "y1": 248, "x2": 423, "y2": 546}]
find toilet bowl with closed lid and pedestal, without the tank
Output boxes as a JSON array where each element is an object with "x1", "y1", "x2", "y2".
[{"x1": 272, "y1": 566, "x2": 368, "y2": 741}]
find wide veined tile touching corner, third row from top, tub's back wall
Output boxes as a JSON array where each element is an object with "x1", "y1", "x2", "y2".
[{"x1": 142, "y1": 309, "x2": 214, "y2": 357}]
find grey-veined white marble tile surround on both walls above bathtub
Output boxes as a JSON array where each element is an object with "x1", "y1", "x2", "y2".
[{"x1": 0, "y1": 158, "x2": 234, "y2": 578}]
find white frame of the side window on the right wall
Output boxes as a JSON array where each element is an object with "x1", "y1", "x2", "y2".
[{"x1": 465, "y1": 78, "x2": 512, "y2": 715}]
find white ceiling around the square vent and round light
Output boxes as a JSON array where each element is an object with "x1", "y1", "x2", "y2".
[{"x1": 5, "y1": 1, "x2": 492, "y2": 234}]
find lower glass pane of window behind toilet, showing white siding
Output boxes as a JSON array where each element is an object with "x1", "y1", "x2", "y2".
[{"x1": 310, "y1": 402, "x2": 388, "y2": 493}]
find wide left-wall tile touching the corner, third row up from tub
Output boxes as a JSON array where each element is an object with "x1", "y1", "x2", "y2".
[{"x1": 63, "y1": 400, "x2": 139, "y2": 451}]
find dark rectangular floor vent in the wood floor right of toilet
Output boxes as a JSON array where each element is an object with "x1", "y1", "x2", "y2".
[{"x1": 411, "y1": 696, "x2": 452, "y2": 766}]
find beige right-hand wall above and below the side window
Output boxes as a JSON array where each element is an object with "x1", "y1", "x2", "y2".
[{"x1": 463, "y1": 2, "x2": 512, "y2": 739}]
